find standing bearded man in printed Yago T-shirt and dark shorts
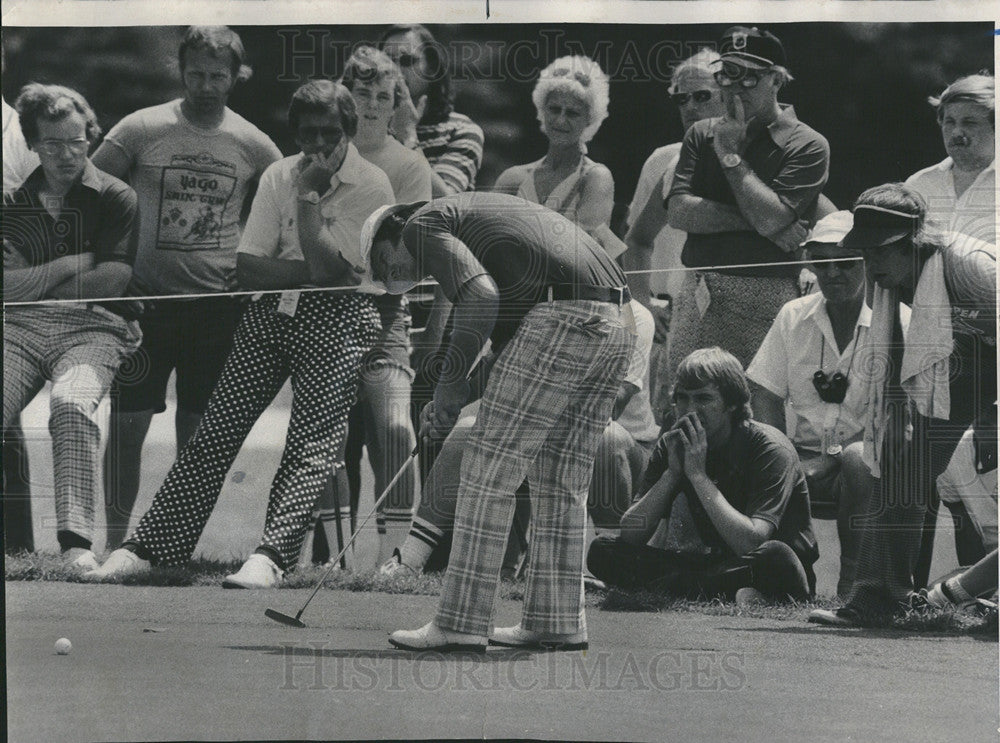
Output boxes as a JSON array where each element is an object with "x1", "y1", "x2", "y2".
[{"x1": 94, "y1": 26, "x2": 281, "y2": 545}]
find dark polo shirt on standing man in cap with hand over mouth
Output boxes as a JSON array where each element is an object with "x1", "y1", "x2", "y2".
[{"x1": 667, "y1": 106, "x2": 830, "y2": 277}]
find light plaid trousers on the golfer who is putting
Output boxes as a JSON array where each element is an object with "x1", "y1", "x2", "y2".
[{"x1": 436, "y1": 300, "x2": 634, "y2": 635}]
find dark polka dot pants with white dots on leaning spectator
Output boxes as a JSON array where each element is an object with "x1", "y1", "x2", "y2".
[{"x1": 128, "y1": 293, "x2": 380, "y2": 567}]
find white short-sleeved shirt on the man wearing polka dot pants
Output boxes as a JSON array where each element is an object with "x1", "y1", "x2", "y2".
[{"x1": 238, "y1": 144, "x2": 394, "y2": 294}]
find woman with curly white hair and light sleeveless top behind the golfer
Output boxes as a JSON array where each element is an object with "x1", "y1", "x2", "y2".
[{"x1": 494, "y1": 56, "x2": 625, "y2": 258}]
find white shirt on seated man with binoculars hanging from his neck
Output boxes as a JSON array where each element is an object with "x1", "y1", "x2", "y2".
[{"x1": 747, "y1": 294, "x2": 909, "y2": 453}]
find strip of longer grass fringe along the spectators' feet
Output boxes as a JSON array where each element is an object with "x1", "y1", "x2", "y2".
[{"x1": 4, "y1": 552, "x2": 998, "y2": 640}]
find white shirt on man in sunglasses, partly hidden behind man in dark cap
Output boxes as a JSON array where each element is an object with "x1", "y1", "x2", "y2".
[{"x1": 628, "y1": 142, "x2": 687, "y2": 298}]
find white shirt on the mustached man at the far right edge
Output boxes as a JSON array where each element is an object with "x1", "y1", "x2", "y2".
[{"x1": 906, "y1": 157, "x2": 997, "y2": 244}]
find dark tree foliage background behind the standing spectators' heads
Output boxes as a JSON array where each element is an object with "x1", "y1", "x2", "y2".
[{"x1": 3, "y1": 23, "x2": 994, "y2": 227}]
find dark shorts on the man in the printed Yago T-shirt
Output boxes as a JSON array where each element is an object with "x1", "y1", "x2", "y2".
[{"x1": 111, "y1": 297, "x2": 244, "y2": 414}]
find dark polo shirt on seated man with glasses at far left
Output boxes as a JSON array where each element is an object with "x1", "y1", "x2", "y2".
[{"x1": 2, "y1": 160, "x2": 141, "y2": 319}]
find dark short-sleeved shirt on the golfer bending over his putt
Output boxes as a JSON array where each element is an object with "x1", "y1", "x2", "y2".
[{"x1": 403, "y1": 192, "x2": 626, "y2": 351}]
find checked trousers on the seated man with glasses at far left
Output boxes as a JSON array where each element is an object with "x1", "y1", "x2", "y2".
[{"x1": 3, "y1": 305, "x2": 142, "y2": 540}]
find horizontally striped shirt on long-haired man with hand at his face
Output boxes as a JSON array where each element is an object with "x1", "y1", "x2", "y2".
[{"x1": 417, "y1": 111, "x2": 483, "y2": 193}]
